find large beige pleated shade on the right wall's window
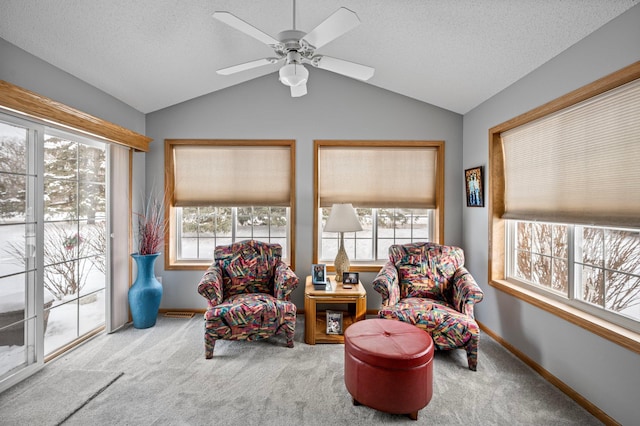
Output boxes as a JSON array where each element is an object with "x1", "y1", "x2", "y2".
[{"x1": 501, "y1": 80, "x2": 640, "y2": 227}]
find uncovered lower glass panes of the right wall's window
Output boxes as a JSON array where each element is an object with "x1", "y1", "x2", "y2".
[{"x1": 507, "y1": 220, "x2": 640, "y2": 329}]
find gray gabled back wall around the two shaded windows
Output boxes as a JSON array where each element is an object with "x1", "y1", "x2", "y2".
[{"x1": 146, "y1": 69, "x2": 463, "y2": 309}]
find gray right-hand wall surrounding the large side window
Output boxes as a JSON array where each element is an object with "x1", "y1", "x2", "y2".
[{"x1": 463, "y1": 6, "x2": 640, "y2": 425}]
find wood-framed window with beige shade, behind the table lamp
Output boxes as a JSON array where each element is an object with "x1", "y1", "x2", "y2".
[{"x1": 314, "y1": 141, "x2": 444, "y2": 271}]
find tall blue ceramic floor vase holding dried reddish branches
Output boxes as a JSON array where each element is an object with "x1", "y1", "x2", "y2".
[{"x1": 129, "y1": 253, "x2": 162, "y2": 328}]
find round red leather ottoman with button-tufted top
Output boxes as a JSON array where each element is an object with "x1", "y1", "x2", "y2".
[{"x1": 344, "y1": 318, "x2": 434, "y2": 420}]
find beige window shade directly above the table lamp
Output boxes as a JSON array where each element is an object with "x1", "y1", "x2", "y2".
[{"x1": 318, "y1": 146, "x2": 438, "y2": 209}]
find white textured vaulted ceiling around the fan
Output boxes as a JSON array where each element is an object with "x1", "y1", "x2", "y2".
[{"x1": 0, "y1": 0, "x2": 640, "y2": 114}]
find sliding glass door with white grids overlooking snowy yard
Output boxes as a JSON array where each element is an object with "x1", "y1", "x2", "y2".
[{"x1": 0, "y1": 114, "x2": 109, "y2": 390}]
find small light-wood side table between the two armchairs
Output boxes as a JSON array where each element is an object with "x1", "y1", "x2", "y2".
[{"x1": 304, "y1": 275, "x2": 367, "y2": 345}]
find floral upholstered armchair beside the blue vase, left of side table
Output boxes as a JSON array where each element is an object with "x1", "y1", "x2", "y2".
[{"x1": 198, "y1": 240, "x2": 299, "y2": 359}]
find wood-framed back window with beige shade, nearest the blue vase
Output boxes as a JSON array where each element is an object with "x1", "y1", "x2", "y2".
[{"x1": 165, "y1": 139, "x2": 295, "y2": 269}]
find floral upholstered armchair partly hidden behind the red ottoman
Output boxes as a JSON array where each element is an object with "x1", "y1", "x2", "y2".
[{"x1": 373, "y1": 243, "x2": 483, "y2": 371}]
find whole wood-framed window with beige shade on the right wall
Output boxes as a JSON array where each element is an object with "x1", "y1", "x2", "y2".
[{"x1": 489, "y1": 60, "x2": 640, "y2": 352}]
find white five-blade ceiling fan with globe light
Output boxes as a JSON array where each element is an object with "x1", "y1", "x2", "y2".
[{"x1": 213, "y1": 0, "x2": 375, "y2": 97}]
